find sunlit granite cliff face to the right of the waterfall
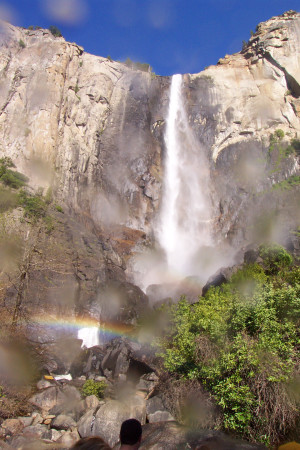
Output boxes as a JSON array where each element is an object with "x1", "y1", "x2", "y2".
[{"x1": 186, "y1": 12, "x2": 300, "y2": 248}]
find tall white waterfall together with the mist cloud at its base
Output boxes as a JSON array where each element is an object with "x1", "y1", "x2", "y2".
[{"x1": 137, "y1": 75, "x2": 233, "y2": 297}]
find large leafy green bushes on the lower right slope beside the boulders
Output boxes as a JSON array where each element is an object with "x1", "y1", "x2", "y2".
[{"x1": 160, "y1": 256, "x2": 300, "y2": 444}]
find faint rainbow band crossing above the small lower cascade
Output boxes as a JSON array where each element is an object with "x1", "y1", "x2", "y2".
[{"x1": 31, "y1": 314, "x2": 136, "y2": 339}]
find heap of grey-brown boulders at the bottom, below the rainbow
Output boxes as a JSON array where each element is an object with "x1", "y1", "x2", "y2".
[{"x1": 0, "y1": 338, "x2": 266, "y2": 450}]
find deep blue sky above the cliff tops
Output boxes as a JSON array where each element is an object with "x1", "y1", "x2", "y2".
[{"x1": 0, "y1": 0, "x2": 300, "y2": 75}]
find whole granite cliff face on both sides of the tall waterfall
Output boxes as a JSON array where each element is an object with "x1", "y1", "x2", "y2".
[{"x1": 0, "y1": 12, "x2": 300, "y2": 326}]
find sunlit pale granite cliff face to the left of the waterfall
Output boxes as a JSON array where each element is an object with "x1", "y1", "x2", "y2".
[{"x1": 0, "y1": 20, "x2": 168, "y2": 236}]
